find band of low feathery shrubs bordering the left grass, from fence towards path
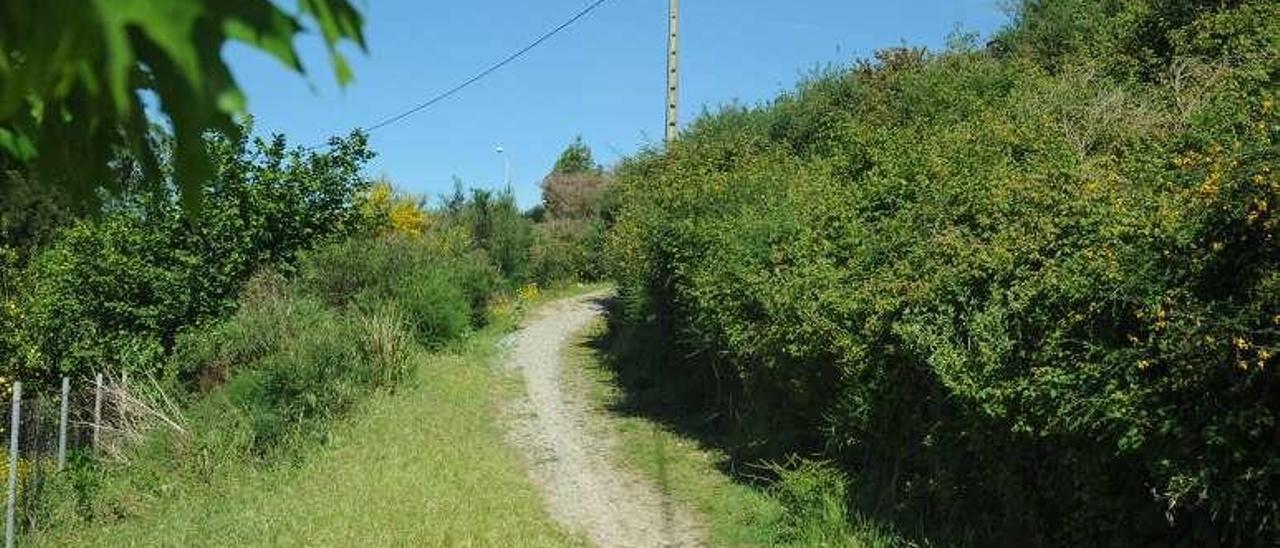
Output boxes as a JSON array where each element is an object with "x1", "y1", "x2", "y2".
[{"x1": 37, "y1": 231, "x2": 497, "y2": 526}]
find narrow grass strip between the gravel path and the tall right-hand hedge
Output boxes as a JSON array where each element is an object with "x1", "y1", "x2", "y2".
[{"x1": 564, "y1": 314, "x2": 918, "y2": 548}]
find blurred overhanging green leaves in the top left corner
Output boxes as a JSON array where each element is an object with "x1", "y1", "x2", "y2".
[{"x1": 0, "y1": 0, "x2": 365, "y2": 207}]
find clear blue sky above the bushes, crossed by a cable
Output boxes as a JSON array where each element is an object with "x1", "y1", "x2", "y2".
[{"x1": 228, "y1": 0, "x2": 1007, "y2": 207}]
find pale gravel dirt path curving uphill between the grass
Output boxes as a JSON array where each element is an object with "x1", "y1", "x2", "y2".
[{"x1": 507, "y1": 293, "x2": 703, "y2": 547}]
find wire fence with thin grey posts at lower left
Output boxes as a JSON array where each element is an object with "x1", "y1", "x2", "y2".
[{"x1": 0, "y1": 375, "x2": 136, "y2": 548}]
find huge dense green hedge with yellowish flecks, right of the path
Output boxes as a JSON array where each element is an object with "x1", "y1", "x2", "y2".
[{"x1": 609, "y1": 0, "x2": 1280, "y2": 545}]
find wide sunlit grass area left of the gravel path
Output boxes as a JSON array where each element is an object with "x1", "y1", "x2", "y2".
[{"x1": 35, "y1": 329, "x2": 581, "y2": 547}]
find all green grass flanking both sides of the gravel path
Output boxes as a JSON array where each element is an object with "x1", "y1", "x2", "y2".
[{"x1": 23, "y1": 286, "x2": 906, "y2": 547}]
